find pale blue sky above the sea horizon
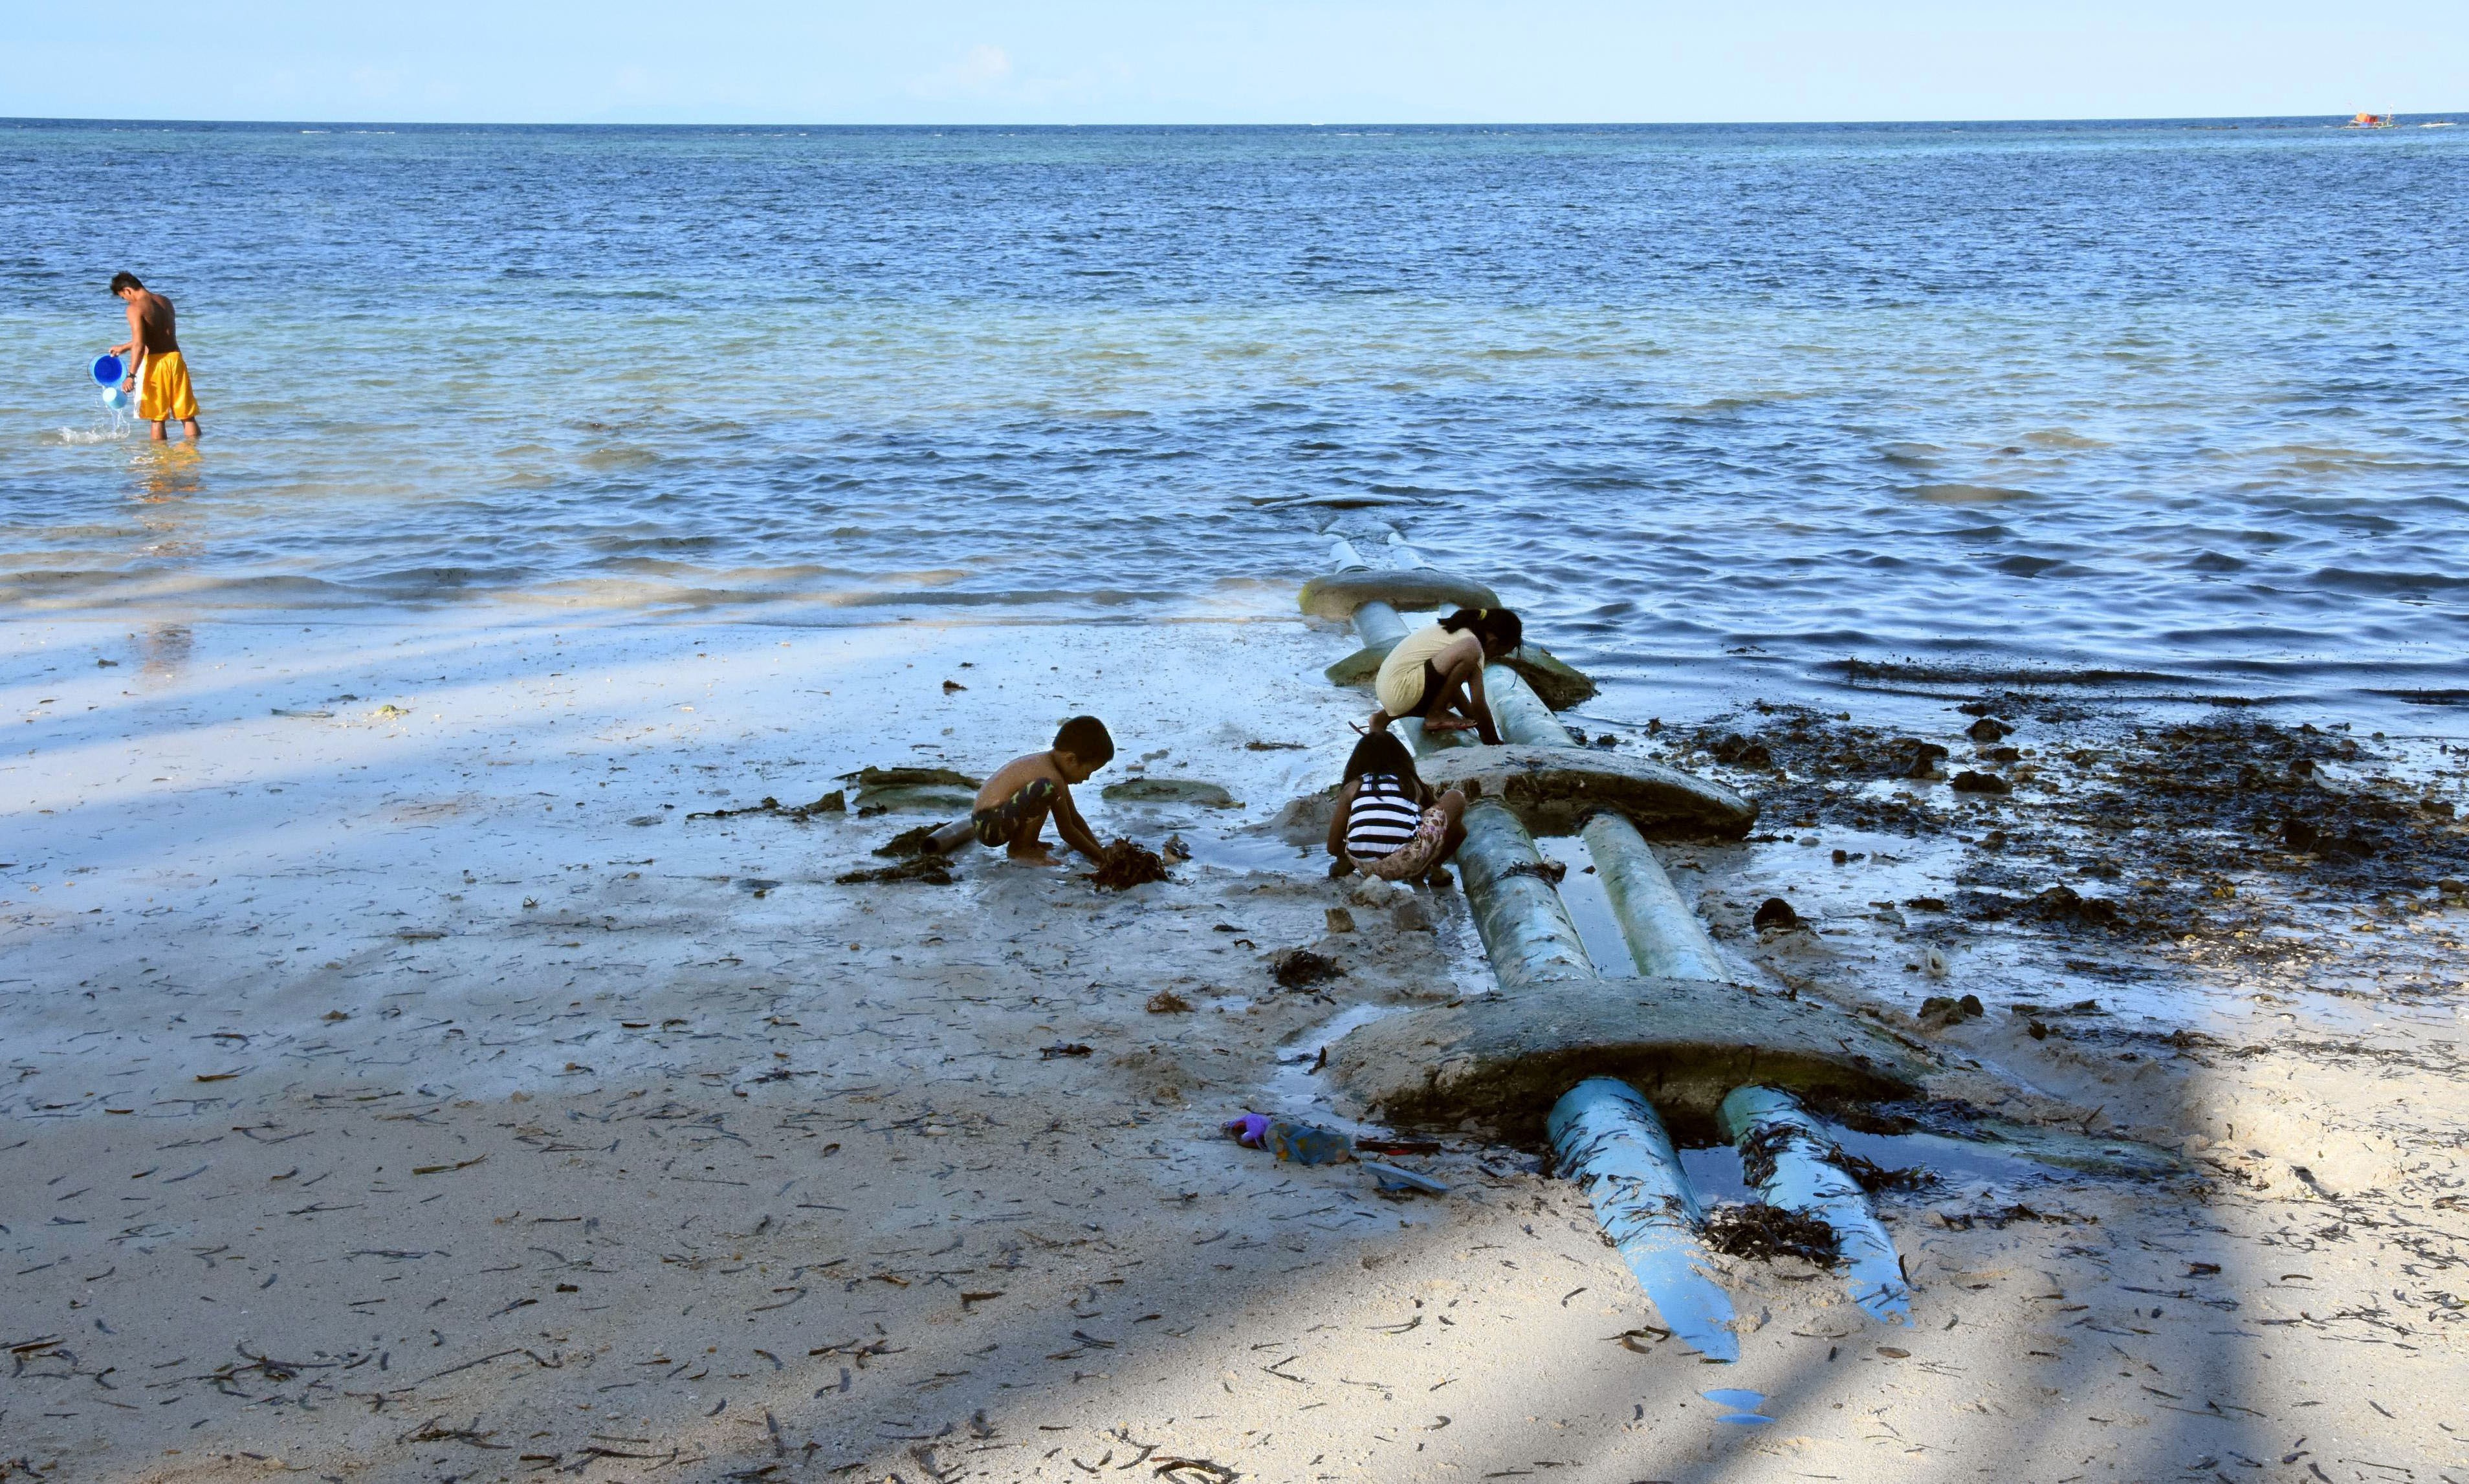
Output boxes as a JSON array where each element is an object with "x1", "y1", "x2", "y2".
[{"x1": 0, "y1": 0, "x2": 2469, "y2": 124}]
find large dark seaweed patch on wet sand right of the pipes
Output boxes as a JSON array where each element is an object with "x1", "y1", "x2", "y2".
[{"x1": 1659, "y1": 692, "x2": 2469, "y2": 953}]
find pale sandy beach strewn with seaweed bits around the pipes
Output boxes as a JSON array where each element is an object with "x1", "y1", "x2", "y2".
[{"x1": 0, "y1": 615, "x2": 2469, "y2": 1484}]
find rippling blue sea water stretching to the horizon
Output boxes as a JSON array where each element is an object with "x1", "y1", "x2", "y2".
[{"x1": 0, "y1": 118, "x2": 2469, "y2": 701}]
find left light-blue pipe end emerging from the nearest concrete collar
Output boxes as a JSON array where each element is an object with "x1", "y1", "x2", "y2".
[{"x1": 1548, "y1": 1076, "x2": 1740, "y2": 1360}]
